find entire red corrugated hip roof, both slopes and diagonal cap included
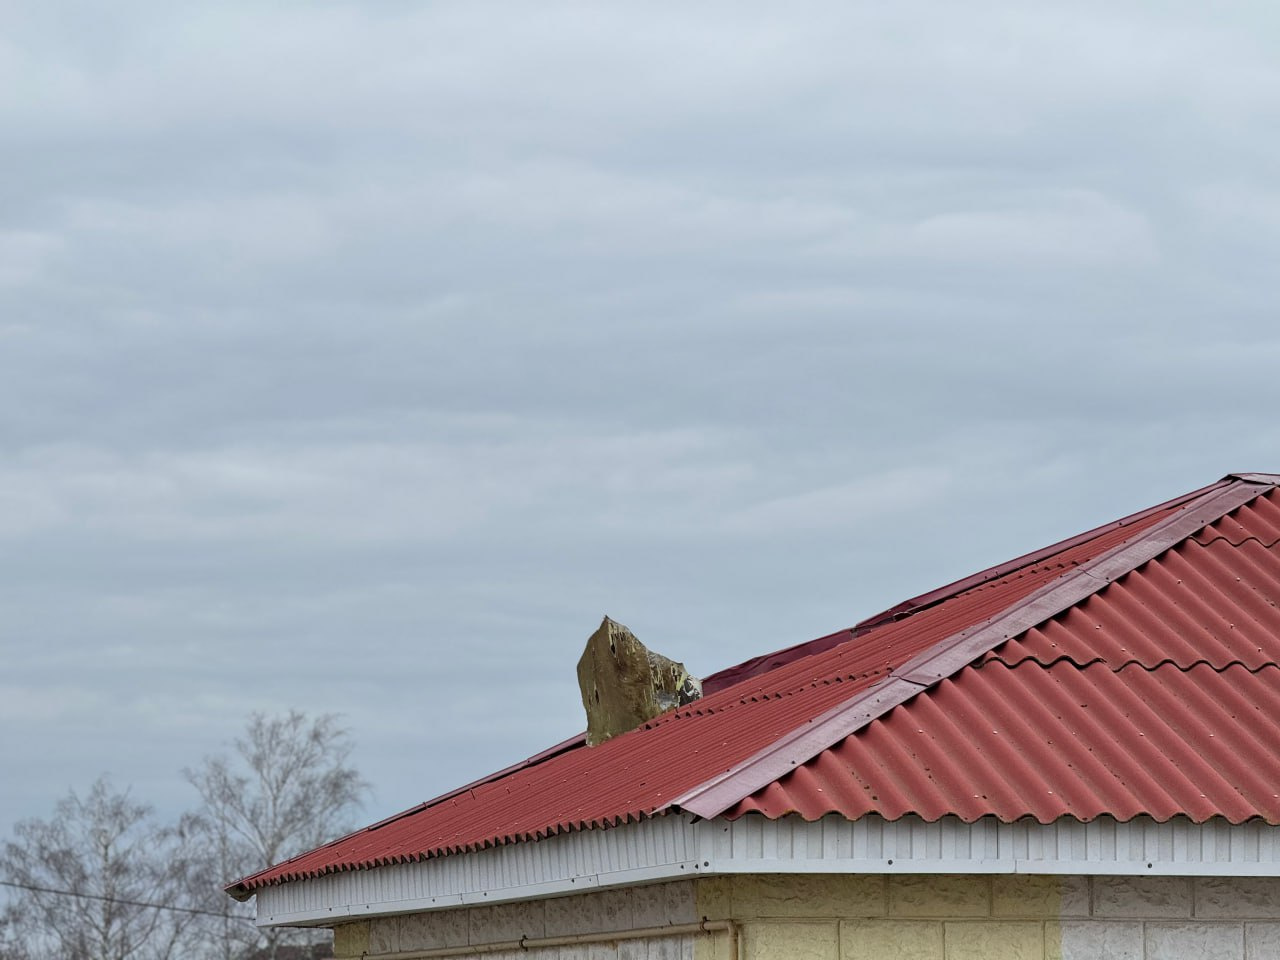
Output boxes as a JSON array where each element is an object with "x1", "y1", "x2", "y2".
[{"x1": 232, "y1": 475, "x2": 1280, "y2": 895}]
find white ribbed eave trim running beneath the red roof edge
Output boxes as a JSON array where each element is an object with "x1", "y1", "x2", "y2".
[{"x1": 257, "y1": 814, "x2": 1280, "y2": 925}]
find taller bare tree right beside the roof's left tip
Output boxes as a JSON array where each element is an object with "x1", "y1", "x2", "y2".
[{"x1": 183, "y1": 710, "x2": 366, "y2": 960}]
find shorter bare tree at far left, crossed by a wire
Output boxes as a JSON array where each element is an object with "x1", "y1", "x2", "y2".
[{"x1": 0, "y1": 777, "x2": 202, "y2": 960}]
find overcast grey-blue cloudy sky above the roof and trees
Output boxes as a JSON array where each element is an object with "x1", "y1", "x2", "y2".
[{"x1": 0, "y1": 0, "x2": 1280, "y2": 832}]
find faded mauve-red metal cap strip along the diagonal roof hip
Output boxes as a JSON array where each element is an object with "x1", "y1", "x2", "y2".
[{"x1": 667, "y1": 475, "x2": 1280, "y2": 819}]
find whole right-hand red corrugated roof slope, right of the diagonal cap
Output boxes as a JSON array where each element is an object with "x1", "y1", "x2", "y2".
[{"x1": 726, "y1": 492, "x2": 1280, "y2": 823}]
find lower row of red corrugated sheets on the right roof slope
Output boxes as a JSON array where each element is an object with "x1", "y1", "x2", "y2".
[{"x1": 726, "y1": 660, "x2": 1280, "y2": 823}]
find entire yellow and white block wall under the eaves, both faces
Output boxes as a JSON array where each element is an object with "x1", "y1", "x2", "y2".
[{"x1": 334, "y1": 874, "x2": 1280, "y2": 960}]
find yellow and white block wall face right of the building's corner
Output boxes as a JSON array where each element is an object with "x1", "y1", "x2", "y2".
[{"x1": 695, "y1": 874, "x2": 1280, "y2": 960}]
